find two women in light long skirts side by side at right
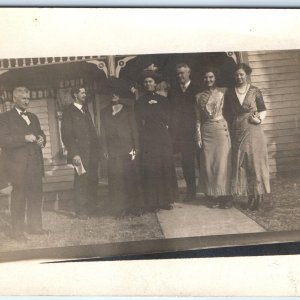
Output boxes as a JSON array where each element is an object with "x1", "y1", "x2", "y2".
[{"x1": 196, "y1": 63, "x2": 270, "y2": 210}]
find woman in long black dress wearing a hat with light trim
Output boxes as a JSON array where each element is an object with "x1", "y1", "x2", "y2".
[{"x1": 135, "y1": 71, "x2": 178, "y2": 211}]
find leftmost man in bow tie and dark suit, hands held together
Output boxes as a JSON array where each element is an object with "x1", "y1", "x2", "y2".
[{"x1": 0, "y1": 87, "x2": 46, "y2": 241}]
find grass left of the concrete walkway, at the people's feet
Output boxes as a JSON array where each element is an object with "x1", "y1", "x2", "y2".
[{"x1": 0, "y1": 196, "x2": 164, "y2": 252}]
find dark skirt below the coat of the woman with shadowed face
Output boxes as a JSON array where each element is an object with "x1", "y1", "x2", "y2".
[{"x1": 108, "y1": 155, "x2": 143, "y2": 214}]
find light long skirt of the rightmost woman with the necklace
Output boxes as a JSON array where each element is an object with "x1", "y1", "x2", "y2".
[{"x1": 232, "y1": 114, "x2": 270, "y2": 196}]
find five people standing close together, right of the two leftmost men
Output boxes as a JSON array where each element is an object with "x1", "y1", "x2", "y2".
[{"x1": 101, "y1": 64, "x2": 270, "y2": 217}]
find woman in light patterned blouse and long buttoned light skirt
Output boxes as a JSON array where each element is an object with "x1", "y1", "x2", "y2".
[{"x1": 196, "y1": 68, "x2": 232, "y2": 208}]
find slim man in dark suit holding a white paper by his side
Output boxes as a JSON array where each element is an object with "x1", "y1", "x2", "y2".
[{"x1": 61, "y1": 87, "x2": 100, "y2": 219}]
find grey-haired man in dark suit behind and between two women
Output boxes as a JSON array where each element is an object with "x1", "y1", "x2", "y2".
[{"x1": 170, "y1": 64, "x2": 199, "y2": 201}]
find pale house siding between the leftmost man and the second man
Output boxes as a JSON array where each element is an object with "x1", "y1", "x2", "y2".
[{"x1": 29, "y1": 99, "x2": 74, "y2": 192}]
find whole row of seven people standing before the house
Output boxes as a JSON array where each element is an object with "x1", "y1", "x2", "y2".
[{"x1": 0, "y1": 64, "x2": 270, "y2": 240}]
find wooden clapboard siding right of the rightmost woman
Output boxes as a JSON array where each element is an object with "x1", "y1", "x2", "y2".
[{"x1": 248, "y1": 50, "x2": 300, "y2": 173}]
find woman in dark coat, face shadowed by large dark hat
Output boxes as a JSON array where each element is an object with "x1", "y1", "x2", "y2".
[{"x1": 101, "y1": 79, "x2": 143, "y2": 216}]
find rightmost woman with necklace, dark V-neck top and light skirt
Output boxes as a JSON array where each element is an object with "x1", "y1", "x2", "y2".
[{"x1": 225, "y1": 64, "x2": 270, "y2": 210}]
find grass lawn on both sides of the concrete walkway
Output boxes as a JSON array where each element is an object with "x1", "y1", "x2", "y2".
[{"x1": 0, "y1": 172, "x2": 300, "y2": 252}]
